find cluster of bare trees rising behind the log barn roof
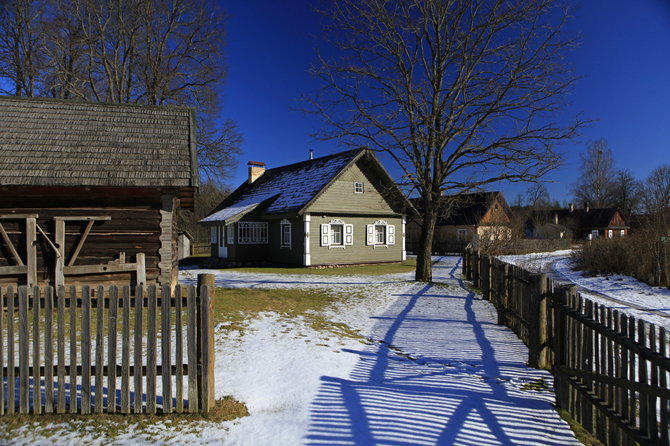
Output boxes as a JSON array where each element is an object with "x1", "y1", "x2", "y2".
[{"x1": 0, "y1": 0, "x2": 241, "y2": 181}]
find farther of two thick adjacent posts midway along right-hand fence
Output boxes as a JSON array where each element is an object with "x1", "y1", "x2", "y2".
[{"x1": 528, "y1": 274, "x2": 547, "y2": 369}]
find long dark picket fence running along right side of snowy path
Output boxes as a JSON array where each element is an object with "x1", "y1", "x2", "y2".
[{"x1": 463, "y1": 249, "x2": 670, "y2": 446}]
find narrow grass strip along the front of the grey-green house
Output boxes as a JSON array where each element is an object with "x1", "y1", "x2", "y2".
[{"x1": 226, "y1": 258, "x2": 416, "y2": 276}]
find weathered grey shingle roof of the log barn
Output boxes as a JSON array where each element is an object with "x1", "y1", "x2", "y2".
[{"x1": 0, "y1": 97, "x2": 198, "y2": 188}]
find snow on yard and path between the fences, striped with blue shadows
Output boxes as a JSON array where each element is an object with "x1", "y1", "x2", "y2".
[{"x1": 5, "y1": 257, "x2": 580, "y2": 446}]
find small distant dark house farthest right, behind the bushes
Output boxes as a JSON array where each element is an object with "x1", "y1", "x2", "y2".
[{"x1": 526, "y1": 203, "x2": 630, "y2": 240}]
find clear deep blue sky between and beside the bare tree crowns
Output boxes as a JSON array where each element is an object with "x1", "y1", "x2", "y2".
[{"x1": 221, "y1": 0, "x2": 670, "y2": 202}]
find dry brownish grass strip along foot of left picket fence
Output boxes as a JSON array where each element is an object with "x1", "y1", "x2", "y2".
[{"x1": 0, "y1": 397, "x2": 249, "y2": 442}]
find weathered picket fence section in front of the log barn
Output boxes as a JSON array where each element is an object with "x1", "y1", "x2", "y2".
[{"x1": 0, "y1": 286, "x2": 214, "y2": 414}]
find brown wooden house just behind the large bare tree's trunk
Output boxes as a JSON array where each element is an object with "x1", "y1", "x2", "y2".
[{"x1": 407, "y1": 192, "x2": 512, "y2": 253}]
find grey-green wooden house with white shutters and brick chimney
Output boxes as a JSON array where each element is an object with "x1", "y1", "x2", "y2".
[{"x1": 200, "y1": 149, "x2": 412, "y2": 266}]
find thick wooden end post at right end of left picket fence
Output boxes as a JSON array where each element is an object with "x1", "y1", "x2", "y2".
[{"x1": 197, "y1": 274, "x2": 214, "y2": 412}]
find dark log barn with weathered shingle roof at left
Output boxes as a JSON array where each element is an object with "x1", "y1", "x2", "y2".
[{"x1": 0, "y1": 97, "x2": 198, "y2": 286}]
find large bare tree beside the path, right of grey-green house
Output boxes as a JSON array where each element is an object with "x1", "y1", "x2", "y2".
[{"x1": 312, "y1": 0, "x2": 582, "y2": 281}]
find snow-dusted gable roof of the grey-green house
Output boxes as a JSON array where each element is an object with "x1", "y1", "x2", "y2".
[{"x1": 200, "y1": 149, "x2": 411, "y2": 223}]
